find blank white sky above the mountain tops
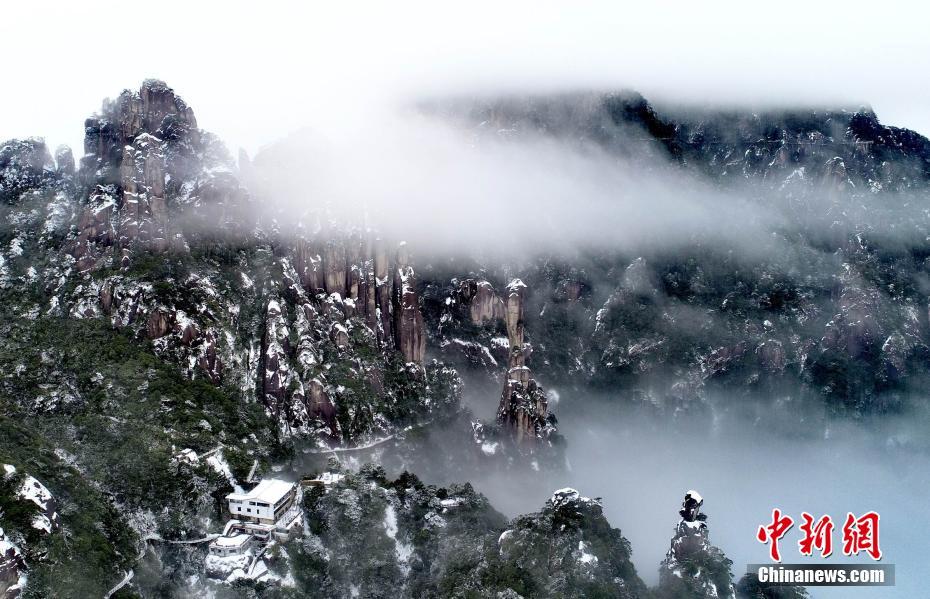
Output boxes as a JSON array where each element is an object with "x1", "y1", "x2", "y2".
[{"x1": 0, "y1": 0, "x2": 930, "y2": 155}]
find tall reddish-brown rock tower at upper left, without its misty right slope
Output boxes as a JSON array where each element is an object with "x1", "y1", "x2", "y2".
[{"x1": 70, "y1": 79, "x2": 210, "y2": 270}]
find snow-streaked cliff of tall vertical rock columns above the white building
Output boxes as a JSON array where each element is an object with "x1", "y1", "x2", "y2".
[{"x1": 254, "y1": 246, "x2": 447, "y2": 442}]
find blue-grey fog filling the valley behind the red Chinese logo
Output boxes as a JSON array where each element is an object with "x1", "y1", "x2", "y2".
[{"x1": 458, "y1": 397, "x2": 930, "y2": 599}]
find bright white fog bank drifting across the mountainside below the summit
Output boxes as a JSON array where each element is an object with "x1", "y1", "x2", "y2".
[{"x1": 245, "y1": 113, "x2": 781, "y2": 258}]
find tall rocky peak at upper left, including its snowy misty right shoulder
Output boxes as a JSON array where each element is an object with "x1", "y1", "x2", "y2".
[{"x1": 71, "y1": 79, "x2": 253, "y2": 270}]
